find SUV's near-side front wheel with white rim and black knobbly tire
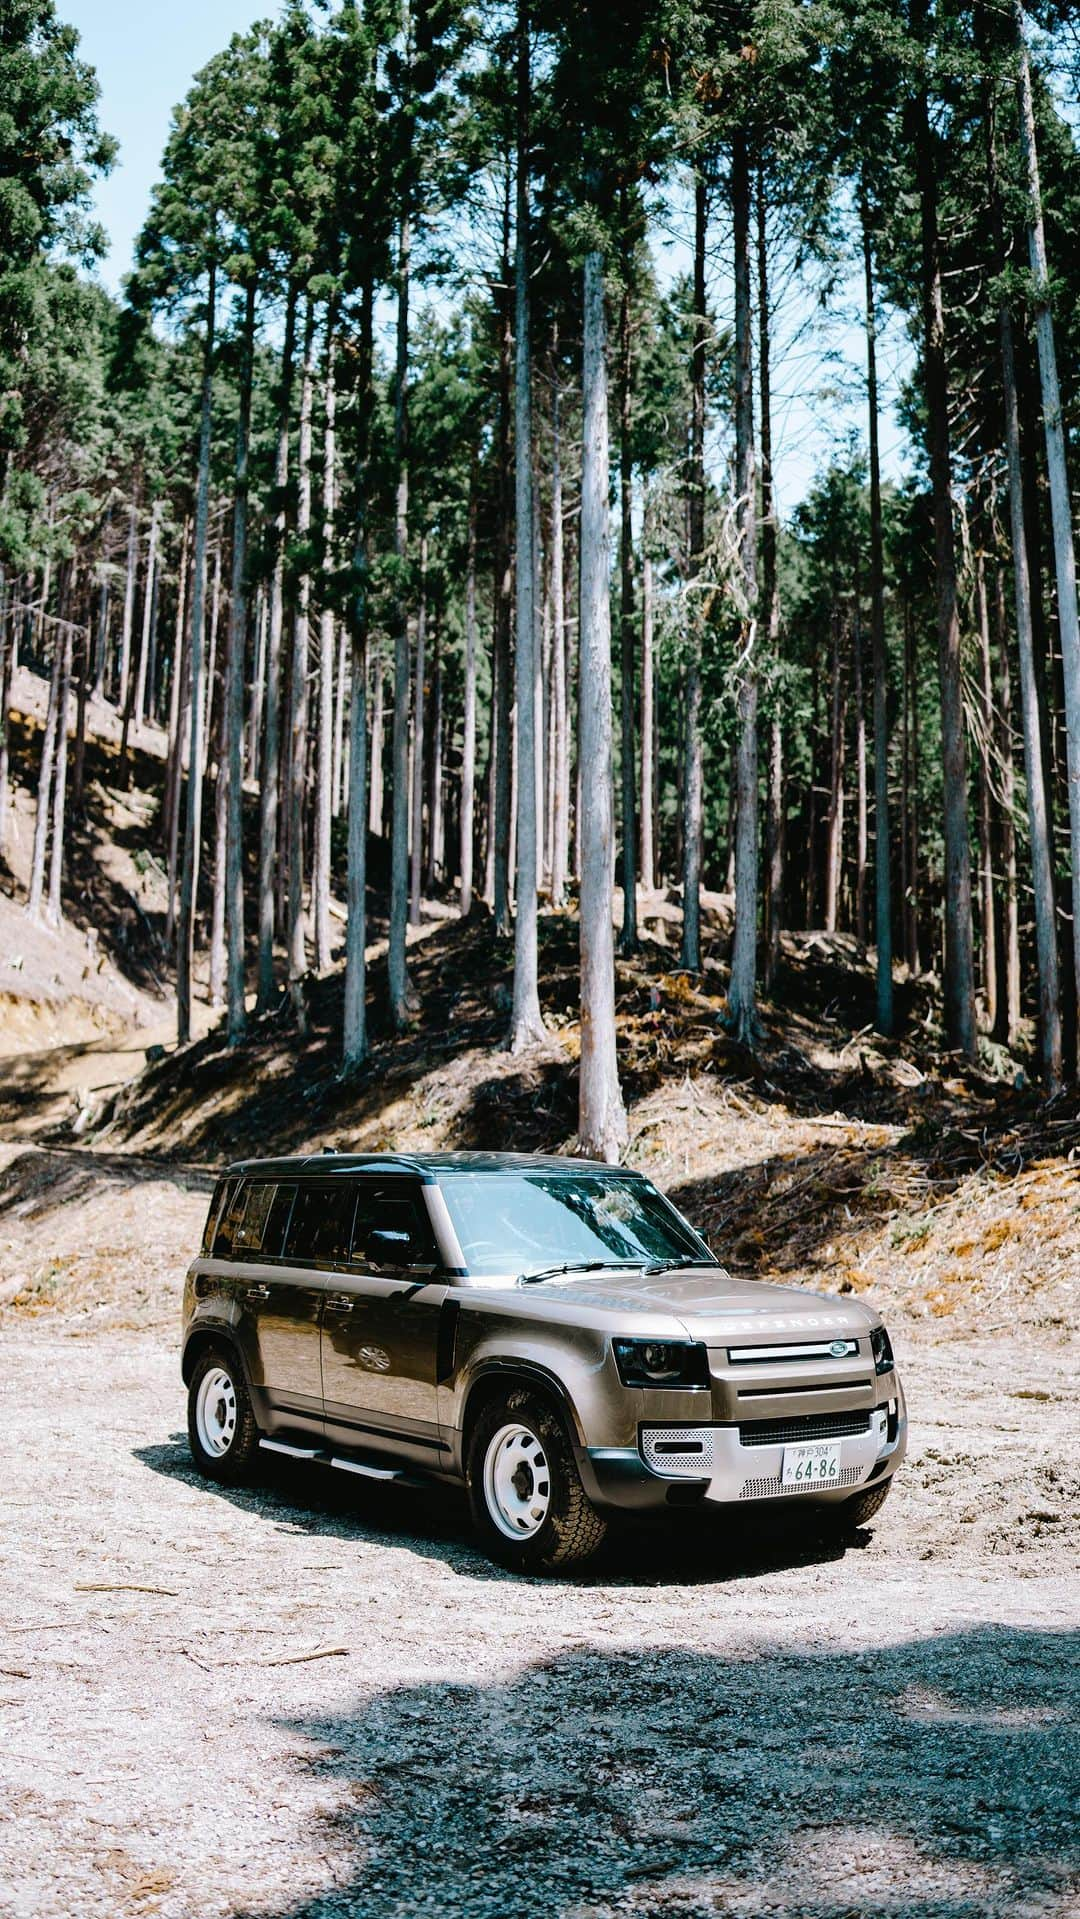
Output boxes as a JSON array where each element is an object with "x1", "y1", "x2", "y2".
[{"x1": 466, "y1": 1387, "x2": 608, "y2": 1574}]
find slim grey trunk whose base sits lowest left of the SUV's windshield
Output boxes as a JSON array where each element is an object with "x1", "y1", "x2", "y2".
[{"x1": 341, "y1": 278, "x2": 382, "y2": 1073}]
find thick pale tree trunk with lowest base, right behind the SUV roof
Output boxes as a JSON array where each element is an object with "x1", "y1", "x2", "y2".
[{"x1": 577, "y1": 253, "x2": 627, "y2": 1163}]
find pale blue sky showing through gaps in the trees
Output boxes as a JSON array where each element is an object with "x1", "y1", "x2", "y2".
[{"x1": 67, "y1": 0, "x2": 911, "y2": 516}]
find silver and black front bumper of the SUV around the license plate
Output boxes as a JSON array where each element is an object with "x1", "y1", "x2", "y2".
[{"x1": 579, "y1": 1395, "x2": 907, "y2": 1510}]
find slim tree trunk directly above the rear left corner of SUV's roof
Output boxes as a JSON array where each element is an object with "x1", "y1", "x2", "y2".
[{"x1": 217, "y1": 280, "x2": 255, "y2": 1046}]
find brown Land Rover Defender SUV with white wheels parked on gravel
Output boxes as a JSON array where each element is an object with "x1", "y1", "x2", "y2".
[{"x1": 182, "y1": 1153, "x2": 907, "y2": 1572}]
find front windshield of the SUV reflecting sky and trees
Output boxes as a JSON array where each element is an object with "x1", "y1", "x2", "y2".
[{"x1": 439, "y1": 1173, "x2": 714, "y2": 1274}]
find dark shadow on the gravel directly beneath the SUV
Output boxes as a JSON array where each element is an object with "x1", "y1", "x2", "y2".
[{"x1": 132, "y1": 1433, "x2": 873, "y2": 1591}]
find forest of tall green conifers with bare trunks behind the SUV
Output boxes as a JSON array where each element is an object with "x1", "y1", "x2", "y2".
[{"x1": 0, "y1": 0, "x2": 1080, "y2": 1157}]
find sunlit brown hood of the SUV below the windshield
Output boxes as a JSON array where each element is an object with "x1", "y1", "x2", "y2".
[{"x1": 517, "y1": 1267, "x2": 879, "y2": 1345}]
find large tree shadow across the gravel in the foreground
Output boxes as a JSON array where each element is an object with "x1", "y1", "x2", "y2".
[{"x1": 246, "y1": 1625, "x2": 1080, "y2": 1919}]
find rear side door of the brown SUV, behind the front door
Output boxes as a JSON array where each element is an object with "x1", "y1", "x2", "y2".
[{"x1": 225, "y1": 1180, "x2": 324, "y2": 1435}]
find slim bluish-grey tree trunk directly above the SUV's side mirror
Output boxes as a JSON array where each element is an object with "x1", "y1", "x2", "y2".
[{"x1": 387, "y1": 196, "x2": 412, "y2": 1031}]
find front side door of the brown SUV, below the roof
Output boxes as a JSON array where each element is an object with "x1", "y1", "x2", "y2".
[{"x1": 322, "y1": 1178, "x2": 447, "y2": 1464}]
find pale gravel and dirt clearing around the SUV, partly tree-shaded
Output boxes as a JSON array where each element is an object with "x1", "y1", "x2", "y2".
[{"x1": 0, "y1": 1132, "x2": 1080, "y2": 1919}]
